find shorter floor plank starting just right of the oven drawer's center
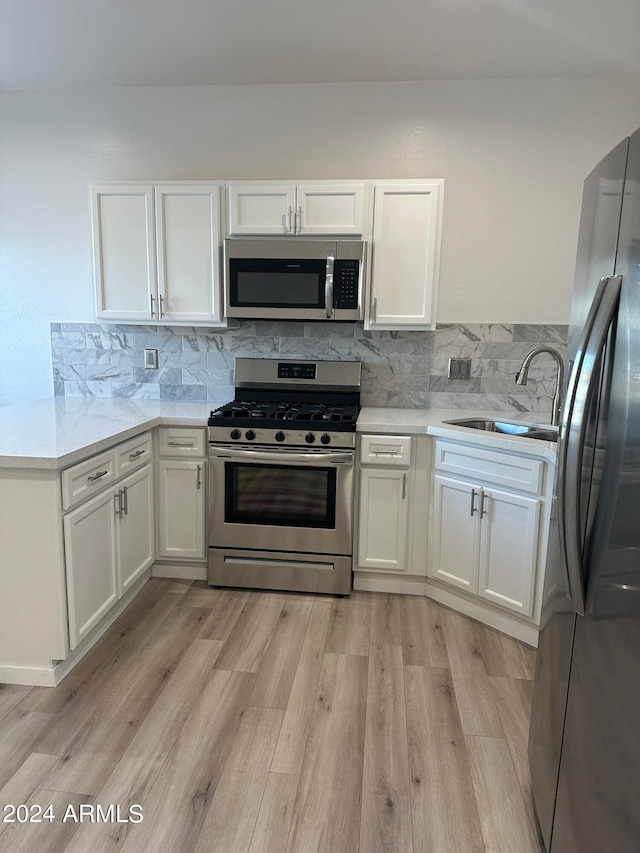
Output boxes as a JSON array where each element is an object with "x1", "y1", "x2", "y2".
[{"x1": 251, "y1": 598, "x2": 313, "y2": 710}]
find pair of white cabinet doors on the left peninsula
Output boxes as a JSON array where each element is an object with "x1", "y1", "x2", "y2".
[{"x1": 64, "y1": 465, "x2": 155, "y2": 649}]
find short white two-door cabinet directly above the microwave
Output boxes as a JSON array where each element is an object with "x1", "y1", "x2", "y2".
[{"x1": 228, "y1": 181, "x2": 368, "y2": 236}]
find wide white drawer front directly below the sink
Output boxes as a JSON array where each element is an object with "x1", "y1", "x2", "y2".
[{"x1": 435, "y1": 441, "x2": 544, "y2": 494}]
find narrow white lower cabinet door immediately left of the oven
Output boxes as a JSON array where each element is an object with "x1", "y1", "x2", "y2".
[{"x1": 158, "y1": 459, "x2": 205, "y2": 560}]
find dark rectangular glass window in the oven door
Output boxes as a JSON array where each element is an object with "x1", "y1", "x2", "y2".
[{"x1": 225, "y1": 462, "x2": 336, "y2": 530}]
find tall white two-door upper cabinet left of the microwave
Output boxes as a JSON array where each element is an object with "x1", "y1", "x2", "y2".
[{"x1": 91, "y1": 182, "x2": 222, "y2": 325}]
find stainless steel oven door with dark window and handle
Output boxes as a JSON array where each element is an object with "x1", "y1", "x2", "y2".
[{"x1": 209, "y1": 445, "x2": 354, "y2": 555}]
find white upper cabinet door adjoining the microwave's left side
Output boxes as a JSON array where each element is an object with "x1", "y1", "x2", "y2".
[{"x1": 155, "y1": 184, "x2": 221, "y2": 323}]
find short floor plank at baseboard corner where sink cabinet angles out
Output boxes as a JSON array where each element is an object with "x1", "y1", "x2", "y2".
[{"x1": 399, "y1": 595, "x2": 449, "y2": 667}]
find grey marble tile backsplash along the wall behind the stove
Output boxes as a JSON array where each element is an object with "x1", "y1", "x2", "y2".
[{"x1": 51, "y1": 320, "x2": 567, "y2": 413}]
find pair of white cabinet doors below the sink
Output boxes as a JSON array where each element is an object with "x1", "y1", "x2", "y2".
[{"x1": 429, "y1": 474, "x2": 541, "y2": 617}]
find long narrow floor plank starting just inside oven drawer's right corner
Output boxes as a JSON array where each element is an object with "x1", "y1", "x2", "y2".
[{"x1": 271, "y1": 598, "x2": 332, "y2": 776}]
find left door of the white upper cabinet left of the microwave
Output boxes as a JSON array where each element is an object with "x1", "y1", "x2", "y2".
[{"x1": 91, "y1": 184, "x2": 157, "y2": 320}]
